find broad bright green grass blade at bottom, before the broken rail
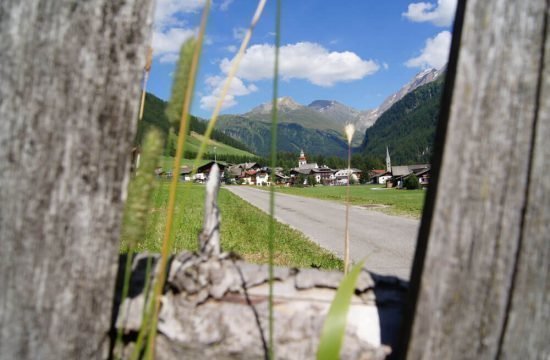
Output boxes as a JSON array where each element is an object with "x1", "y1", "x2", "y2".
[{"x1": 317, "y1": 261, "x2": 364, "y2": 360}]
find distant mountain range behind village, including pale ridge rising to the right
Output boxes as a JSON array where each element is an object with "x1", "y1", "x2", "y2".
[{"x1": 217, "y1": 69, "x2": 444, "y2": 156}]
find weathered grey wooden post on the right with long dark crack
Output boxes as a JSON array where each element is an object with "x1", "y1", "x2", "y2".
[{"x1": 407, "y1": 0, "x2": 550, "y2": 359}]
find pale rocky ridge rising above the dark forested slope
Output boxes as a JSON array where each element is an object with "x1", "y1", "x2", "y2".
[{"x1": 356, "y1": 67, "x2": 446, "y2": 131}]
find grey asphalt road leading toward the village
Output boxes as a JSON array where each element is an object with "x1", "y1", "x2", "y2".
[{"x1": 224, "y1": 186, "x2": 420, "y2": 280}]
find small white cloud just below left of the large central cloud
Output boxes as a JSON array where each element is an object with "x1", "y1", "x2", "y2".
[{"x1": 200, "y1": 76, "x2": 258, "y2": 110}]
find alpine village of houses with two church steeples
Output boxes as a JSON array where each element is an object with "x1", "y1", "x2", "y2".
[{"x1": 155, "y1": 150, "x2": 431, "y2": 189}]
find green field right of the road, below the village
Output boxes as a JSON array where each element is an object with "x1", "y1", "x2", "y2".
[{"x1": 276, "y1": 185, "x2": 426, "y2": 219}]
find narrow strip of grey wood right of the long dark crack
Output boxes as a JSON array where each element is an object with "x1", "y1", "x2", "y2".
[{"x1": 501, "y1": 3, "x2": 550, "y2": 359}]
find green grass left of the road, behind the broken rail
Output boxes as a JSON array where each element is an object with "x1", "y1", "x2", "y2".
[{"x1": 129, "y1": 183, "x2": 343, "y2": 270}]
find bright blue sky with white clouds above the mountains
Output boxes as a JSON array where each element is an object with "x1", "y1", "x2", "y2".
[{"x1": 147, "y1": 0, "x2": 456, "y2": 118}]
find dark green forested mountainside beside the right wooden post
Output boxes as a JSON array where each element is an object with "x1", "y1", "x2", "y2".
[{"x1": 361, "y1": 76, "x2": 444, "y2": 165}]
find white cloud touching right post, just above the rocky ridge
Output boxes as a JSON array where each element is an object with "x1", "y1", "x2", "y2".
[{"x1": 405, "y1": 31, "x2": 451, "y2": 69}]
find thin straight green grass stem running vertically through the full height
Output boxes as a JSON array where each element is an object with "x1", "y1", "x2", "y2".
[{"x1": 268, "y1": 0, "x2": 281, "y2": 359}]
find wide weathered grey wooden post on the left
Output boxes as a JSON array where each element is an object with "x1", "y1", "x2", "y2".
[{"x1": 0, "y1": 0, "x2": 152, "y2": 359}]
